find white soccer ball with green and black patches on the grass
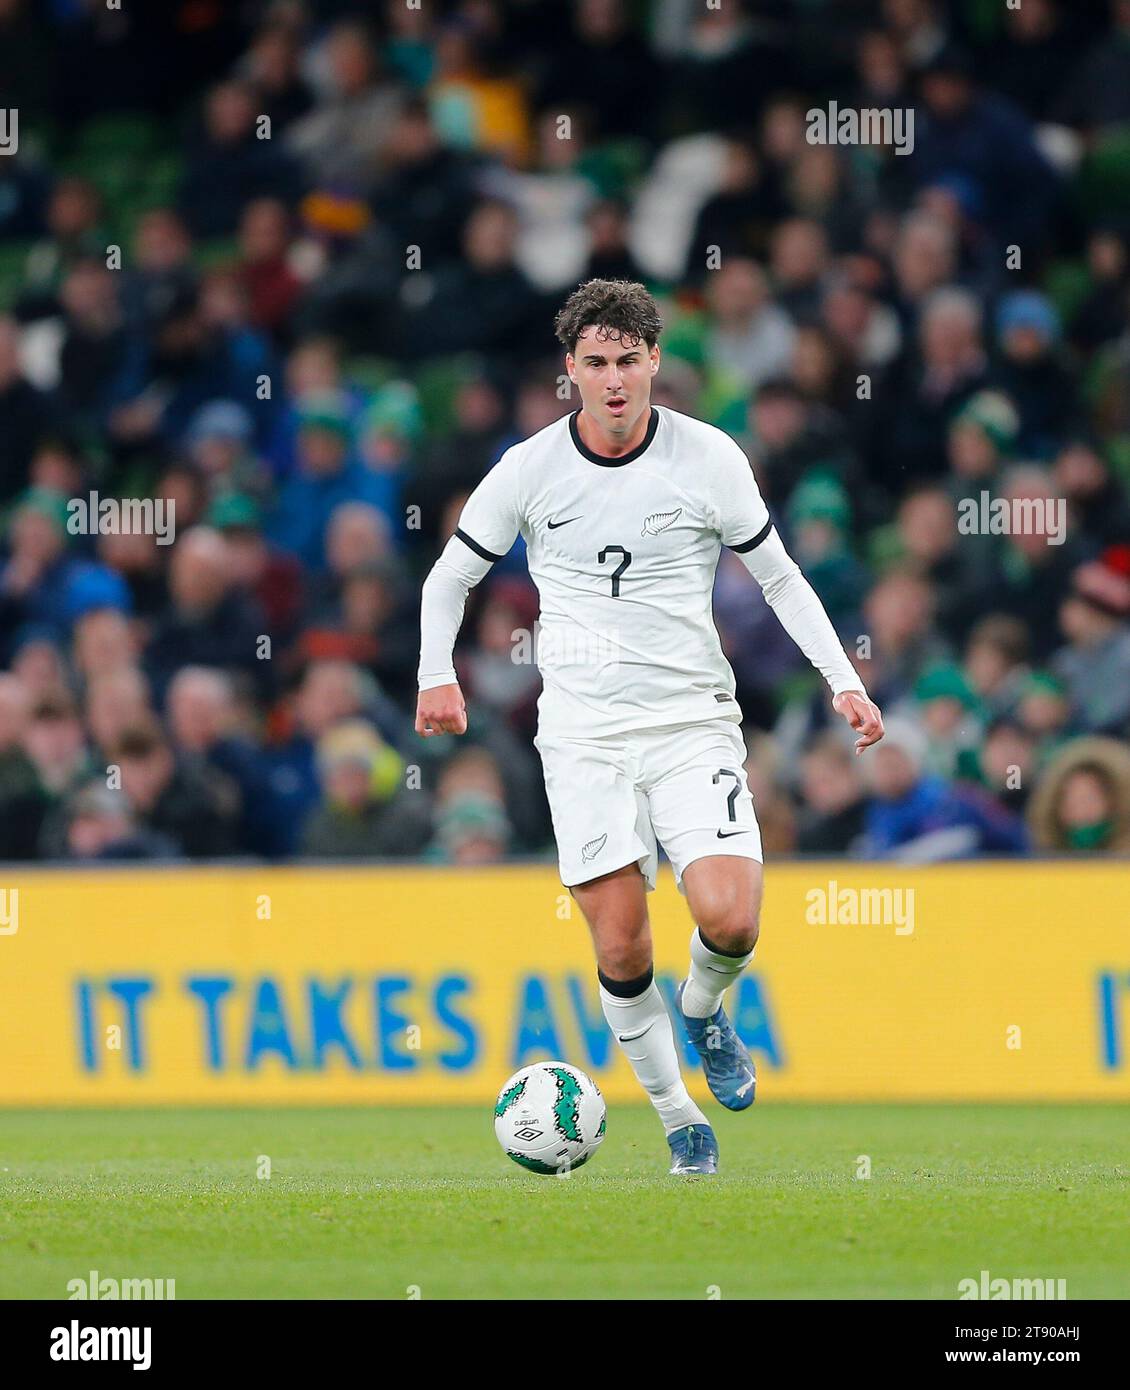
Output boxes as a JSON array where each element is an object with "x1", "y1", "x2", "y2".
[{"x1": 495, "y1": 1062, "x2": 605, "y2": 1175}]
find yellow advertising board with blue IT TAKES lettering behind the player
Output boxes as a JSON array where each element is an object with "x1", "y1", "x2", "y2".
[{"x1": 0, "y1": 862, "x2": 1130, "y2": 1105}]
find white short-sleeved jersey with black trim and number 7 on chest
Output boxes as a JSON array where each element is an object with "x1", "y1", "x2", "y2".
[{"x1": 445, "y1": 406, "x2": 771, "y2": 737}]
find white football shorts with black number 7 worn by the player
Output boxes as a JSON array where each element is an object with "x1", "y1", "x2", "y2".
[{"x1": 534, "y1": 719, "x2": 762, "y2": 892}]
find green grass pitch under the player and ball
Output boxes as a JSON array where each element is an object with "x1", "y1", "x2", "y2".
[{"x1": 0, "y1": 1104, "x2": 1130, "y2": 1300}]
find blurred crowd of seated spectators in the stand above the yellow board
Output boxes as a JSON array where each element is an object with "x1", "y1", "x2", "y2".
[{"x1": 0, "y1": 0, "x2": 1130, "y2": 863}]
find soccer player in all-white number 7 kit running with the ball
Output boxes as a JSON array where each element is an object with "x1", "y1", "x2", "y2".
[{"x1": 416, "y1": 279, "x2": 883, "y2": 1175}]
